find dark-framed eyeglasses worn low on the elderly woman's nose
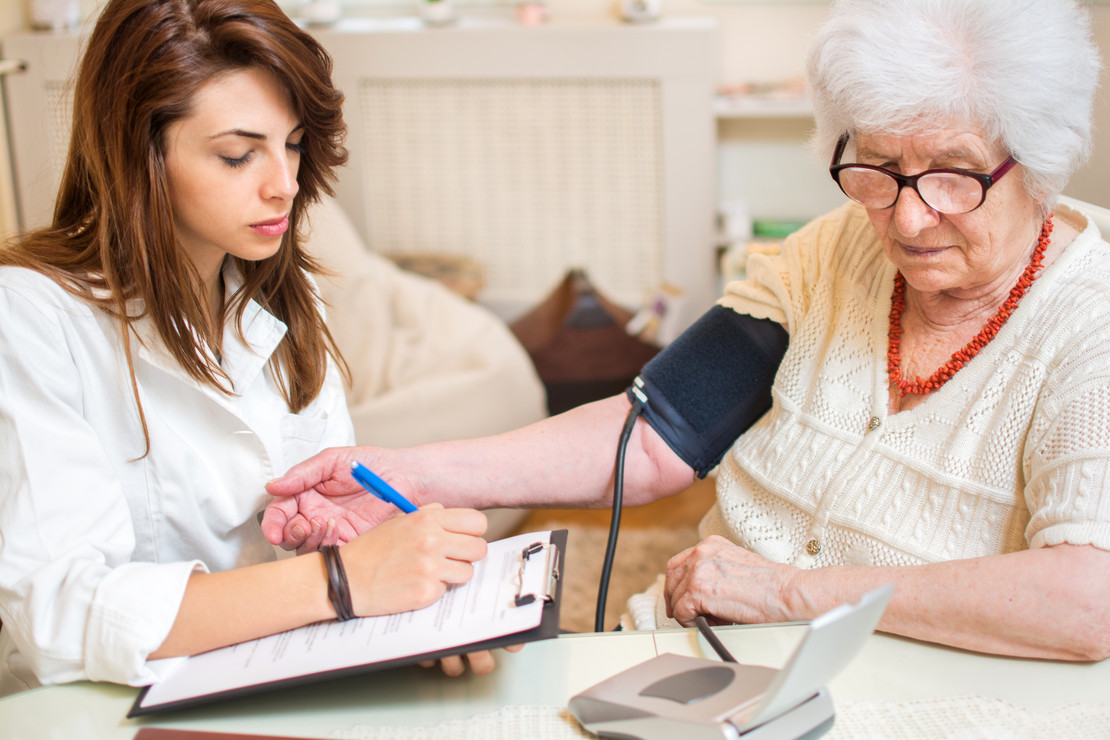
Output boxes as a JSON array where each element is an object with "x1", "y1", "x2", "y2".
[{"x1": 829, "y1": 134, "x2": 1018, "y2": 214}]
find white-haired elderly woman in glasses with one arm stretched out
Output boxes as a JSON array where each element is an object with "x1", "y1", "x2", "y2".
[{"x1": 266, "y1": 0, "x2": 1110, "y2": 660}]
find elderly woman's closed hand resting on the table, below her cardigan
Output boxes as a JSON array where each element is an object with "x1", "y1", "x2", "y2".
[{"x1": 665, "y1": 535, "x2": 797, "y2": 627}]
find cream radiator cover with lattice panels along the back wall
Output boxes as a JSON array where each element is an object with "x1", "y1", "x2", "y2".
[{"x1": 3, "y1": 19, "x2": 717, "y2": 325}]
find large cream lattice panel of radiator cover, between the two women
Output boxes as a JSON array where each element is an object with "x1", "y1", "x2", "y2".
[{"x1": 357, "y1": 80, "x2": 663, "y2": 310}]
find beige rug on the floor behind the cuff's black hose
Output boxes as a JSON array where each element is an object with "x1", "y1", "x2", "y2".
[{"x1": 545, "y1": 520, "x2": 699, "y2": 632}]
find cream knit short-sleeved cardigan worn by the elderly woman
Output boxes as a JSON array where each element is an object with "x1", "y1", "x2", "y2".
[{"x1": 629, "y1": 204, "x2": 1110, "y2": 628}]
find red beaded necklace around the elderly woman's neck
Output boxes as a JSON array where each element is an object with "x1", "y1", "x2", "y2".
[{"x1": 887, "y1": 213, "x2": 1052, "y2": 397}]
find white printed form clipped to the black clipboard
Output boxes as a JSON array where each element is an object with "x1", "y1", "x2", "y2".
[{"x1": 140, "y1": 531, "x2": 551, "y2": 707}]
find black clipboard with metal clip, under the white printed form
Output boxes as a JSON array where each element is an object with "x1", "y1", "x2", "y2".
[{"x1": 128, "y1": 529, "x2": 567, "y2": 718}]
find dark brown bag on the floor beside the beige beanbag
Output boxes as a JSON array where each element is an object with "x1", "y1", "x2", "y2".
[{"x1": 509, "y1": 270, "x2": 659, "y2": 414}]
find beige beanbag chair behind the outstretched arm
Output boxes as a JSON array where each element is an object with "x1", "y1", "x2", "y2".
[{"x1": 307, "y1": 199, "x2": 547, "y2": 538}]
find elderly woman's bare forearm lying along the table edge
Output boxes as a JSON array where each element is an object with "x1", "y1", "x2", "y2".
[{"x1": 788, "y1": 546, "x2": 1110, "y2": 660}]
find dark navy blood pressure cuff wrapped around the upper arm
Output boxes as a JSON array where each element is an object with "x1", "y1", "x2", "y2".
[{"x1": 627, "y1": 306, "x2": 789, "y2": 478}]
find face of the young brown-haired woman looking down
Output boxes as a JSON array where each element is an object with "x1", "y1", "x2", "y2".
[{"x1": 165, "y1": 69, "x2": 304, "y2": 283}]
